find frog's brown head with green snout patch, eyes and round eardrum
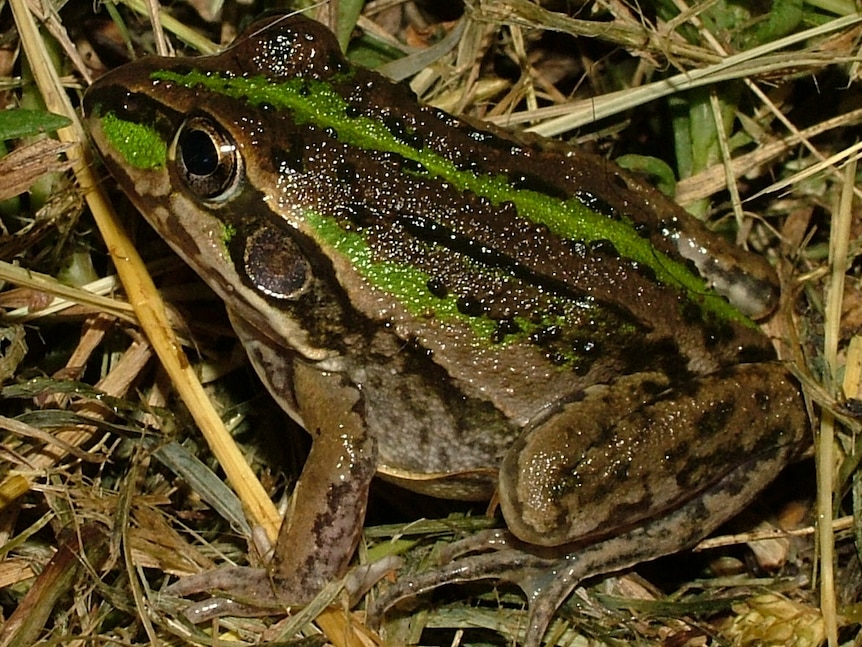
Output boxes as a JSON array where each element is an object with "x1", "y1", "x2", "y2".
[{"x1": 84, "y1": 15, "x2": 370, "y2": 359}]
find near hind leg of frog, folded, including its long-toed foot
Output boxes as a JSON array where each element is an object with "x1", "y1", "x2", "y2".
[{"x1": 369, "y1": 363, "x2": 807, "y2": 647}]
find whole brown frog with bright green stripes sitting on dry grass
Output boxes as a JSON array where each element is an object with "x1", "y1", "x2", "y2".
[{"x1": 83, "y1": 13, "x2": 808, "y2": 647}]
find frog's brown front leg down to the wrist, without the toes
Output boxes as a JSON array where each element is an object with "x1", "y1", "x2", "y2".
[{"x1": 271, "y1": 362, "x2": 377, "y2": 595}]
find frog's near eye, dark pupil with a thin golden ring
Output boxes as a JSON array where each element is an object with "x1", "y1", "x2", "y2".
[{"x1": 174, "y1": 117, "x2": 242, "y2": 202}]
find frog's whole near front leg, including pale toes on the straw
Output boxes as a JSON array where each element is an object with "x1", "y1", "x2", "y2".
[{"x1": 167, "y1": 354, "x2": 377, "y2": 622}]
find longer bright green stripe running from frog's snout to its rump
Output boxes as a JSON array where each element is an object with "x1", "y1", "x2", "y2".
[{"x1": 151, "y1": 70, "x2": 754, "y2": 326}]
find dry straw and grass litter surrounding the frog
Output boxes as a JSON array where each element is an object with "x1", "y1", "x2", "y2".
[{"x1": 0, "y1": 0, "x2": 862, "y2": 647}]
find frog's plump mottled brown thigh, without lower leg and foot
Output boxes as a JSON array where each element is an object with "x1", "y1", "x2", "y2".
[{"x1": 500, "y1": 363, "x2": 806, "y2": 546}]
